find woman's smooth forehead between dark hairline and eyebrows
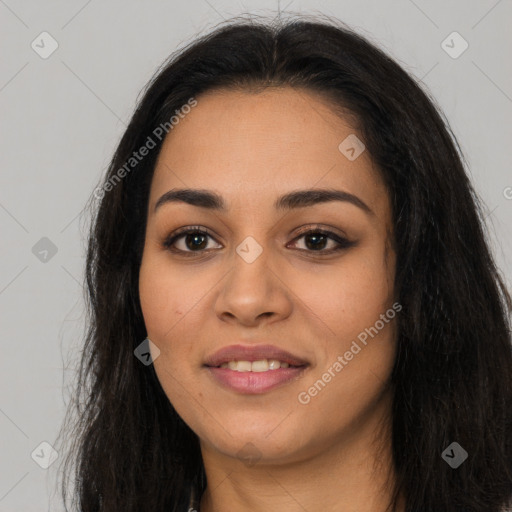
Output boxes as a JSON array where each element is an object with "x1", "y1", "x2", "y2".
[{"x1": 150, "y1": 87, "x2": 385, "y2": 215}]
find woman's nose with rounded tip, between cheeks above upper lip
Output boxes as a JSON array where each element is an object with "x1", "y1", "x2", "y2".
[{"x1": 215, "y1": 241, "x2": 293, "y2": 327}]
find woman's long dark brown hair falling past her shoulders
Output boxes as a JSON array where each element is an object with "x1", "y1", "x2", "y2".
[{"x1": 57, "y1": 12, "x2": 512, "y2": 512}]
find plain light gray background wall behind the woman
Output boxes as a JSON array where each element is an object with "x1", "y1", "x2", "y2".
[{"x1": 0, "y1": 0, "x2": 512, "y2": 512}]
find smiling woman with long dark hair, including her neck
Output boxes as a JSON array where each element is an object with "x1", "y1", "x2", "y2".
[{"x1": 58, "y1": 12, "x2": 512, "y2": 512}]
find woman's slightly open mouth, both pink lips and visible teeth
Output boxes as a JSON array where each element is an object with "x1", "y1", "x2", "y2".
[{"x1": 204, "y1": 345, "x2": 309, "y2": 394}]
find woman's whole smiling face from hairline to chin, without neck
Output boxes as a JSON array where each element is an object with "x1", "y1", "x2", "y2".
[{"x1": 139, "y1": 88, "x2": 400, "y2": 463}]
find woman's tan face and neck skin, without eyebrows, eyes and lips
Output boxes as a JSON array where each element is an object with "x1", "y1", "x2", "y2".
[{"x1": 139, "y1": 87, "x2": 401, "y2": 512}]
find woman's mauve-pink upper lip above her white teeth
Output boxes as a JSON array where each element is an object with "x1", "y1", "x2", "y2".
[{"x1": 204, "y1": 345, "x2": 308, "y2": 367}]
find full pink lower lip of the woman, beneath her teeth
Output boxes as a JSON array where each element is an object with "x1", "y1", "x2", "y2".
[{"x1": 207, "y1": 366, "x2": 306, "y2": 395}]
